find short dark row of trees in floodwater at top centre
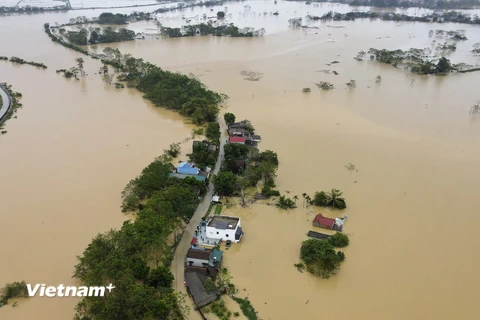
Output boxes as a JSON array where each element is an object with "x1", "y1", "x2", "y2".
[{"x1": 161, "y1": 21, "x2": 265, "y2": 38}]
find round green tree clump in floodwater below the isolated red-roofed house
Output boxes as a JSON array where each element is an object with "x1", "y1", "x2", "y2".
[{"x1": 300, "y1": 233, "x2": 350, "y2": 279}]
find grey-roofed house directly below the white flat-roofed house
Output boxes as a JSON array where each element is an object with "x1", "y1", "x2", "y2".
[{"x1": 185, "y1": 248, "x2": 223, "y2": 279}]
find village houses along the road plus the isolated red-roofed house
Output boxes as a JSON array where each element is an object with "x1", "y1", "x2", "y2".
[{"x1": 170, "y1": 120, "x2": 347, "y2": 319}]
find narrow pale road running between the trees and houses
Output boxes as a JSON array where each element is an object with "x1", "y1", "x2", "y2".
[{"x1": 171, "y1": 116, "x2": 227, "y2": 320}]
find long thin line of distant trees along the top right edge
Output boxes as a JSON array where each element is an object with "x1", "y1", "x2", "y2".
[{"x1": 307, "y1": 11, "x2": 480, "y2": 24}]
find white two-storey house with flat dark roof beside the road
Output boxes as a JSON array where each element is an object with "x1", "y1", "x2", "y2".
[{"x1": 205, "y1": 216, "x2": 243, "y2": 243}]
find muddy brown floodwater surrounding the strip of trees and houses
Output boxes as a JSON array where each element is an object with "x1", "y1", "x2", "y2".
[{"x1": 0, "y1": 1, "x2": 480, "y2": 320}]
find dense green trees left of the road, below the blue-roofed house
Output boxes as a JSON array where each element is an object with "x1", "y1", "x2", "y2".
[{"x1": 74, "y1": 155, "x2": 210, "y2": 320}]
